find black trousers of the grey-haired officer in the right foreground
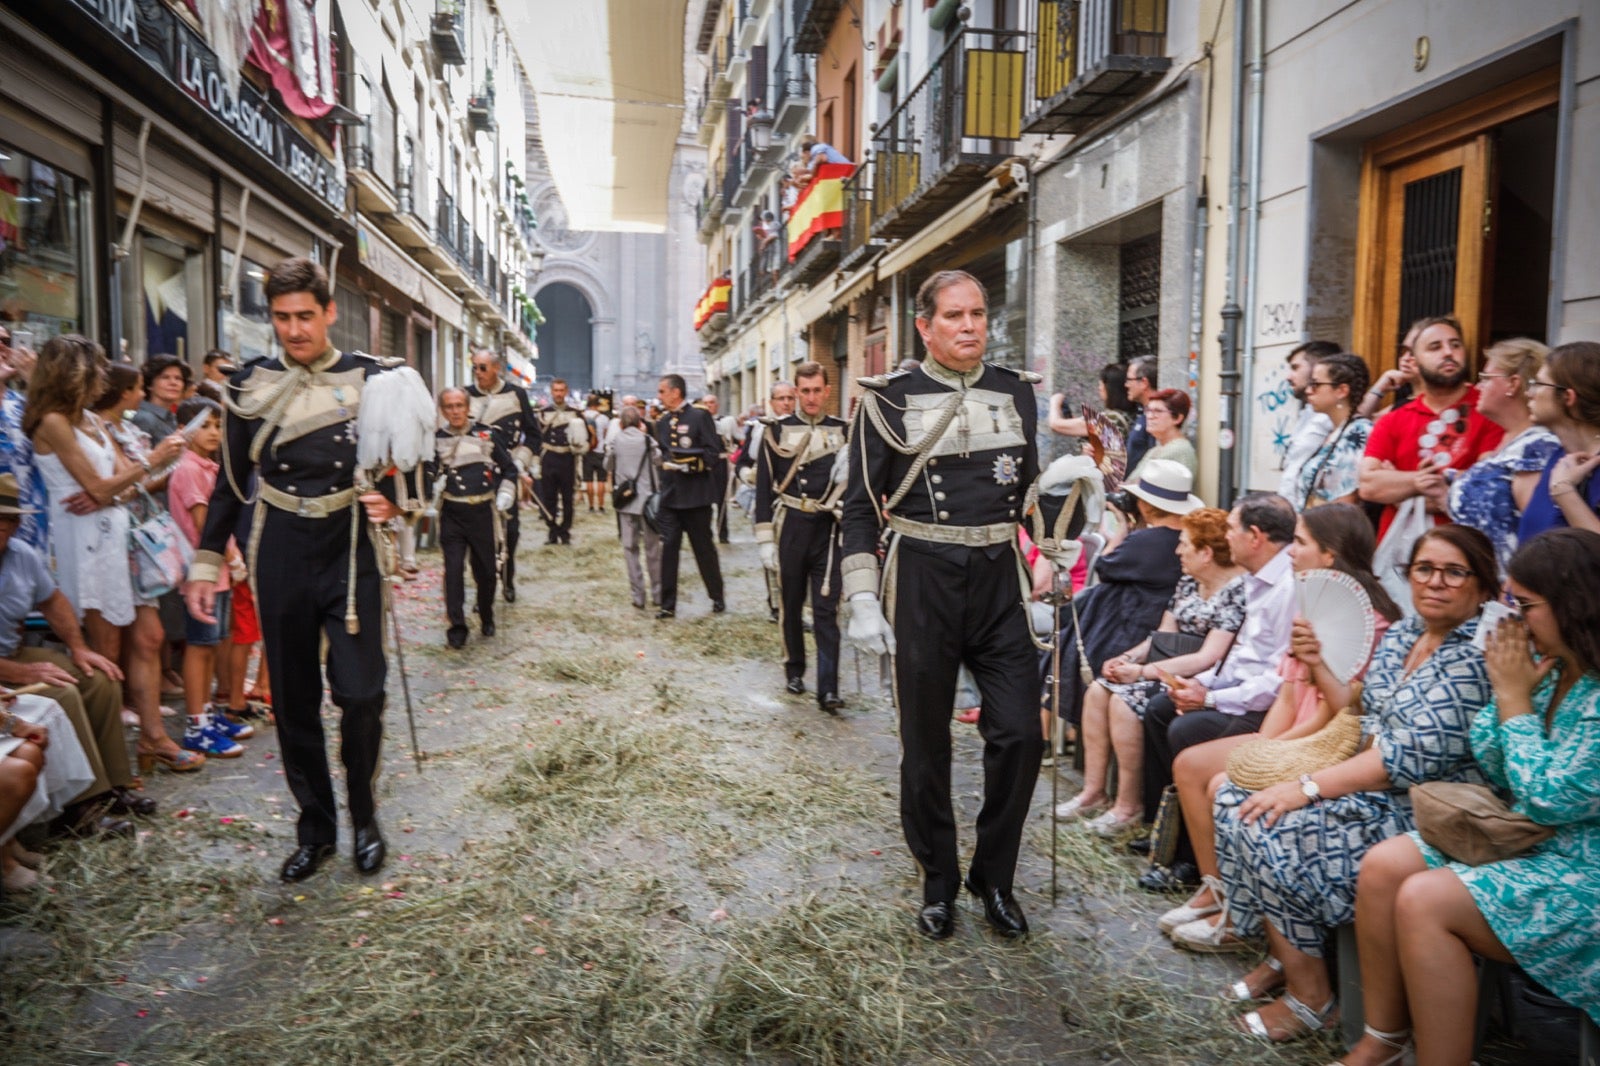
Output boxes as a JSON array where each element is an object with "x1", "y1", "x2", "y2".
[{"x1": 890, "y1": 538, "x2": 1045, "y2": 903}]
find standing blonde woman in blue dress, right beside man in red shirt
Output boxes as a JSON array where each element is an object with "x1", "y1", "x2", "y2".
[{"x1": 1446, "y1": 336, "x2": 1562, "y2": 573}]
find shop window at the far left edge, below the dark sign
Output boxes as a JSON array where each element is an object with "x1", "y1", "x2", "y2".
[{"x1": 0, "y1": 144, "x2": 90, "y2": 347}]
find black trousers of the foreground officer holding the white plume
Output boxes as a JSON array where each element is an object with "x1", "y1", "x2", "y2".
[{"x1": 251, "y1": 503, "x2": 386, "y2": 844}]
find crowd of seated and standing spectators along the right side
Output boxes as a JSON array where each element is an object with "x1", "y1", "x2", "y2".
[{"x1": 1043, "y1": 332, "x2": 1600, "y2": 1066}]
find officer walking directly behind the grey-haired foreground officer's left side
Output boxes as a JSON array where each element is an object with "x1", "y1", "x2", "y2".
[{"x1": 755, "y1": 363, "x2": 846, "y2": 714}]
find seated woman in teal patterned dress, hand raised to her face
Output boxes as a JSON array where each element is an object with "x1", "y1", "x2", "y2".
[{"x1": 1344, "y1": 530, "x2": 1600, "y2": 1066}]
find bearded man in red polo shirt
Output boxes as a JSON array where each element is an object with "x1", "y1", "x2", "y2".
[{"x1": 1360, "y1": 315, "x2": 1506, "y2": 539}]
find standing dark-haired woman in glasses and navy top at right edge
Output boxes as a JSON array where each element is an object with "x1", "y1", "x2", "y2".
[{"x1": 1517, "y1": 341, "x2": 1600, "y2": 539}]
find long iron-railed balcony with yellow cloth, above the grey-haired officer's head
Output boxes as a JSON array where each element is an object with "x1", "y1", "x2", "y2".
[{"x1": 872, "y1": 29, "x2": 1027, "y2": 238}]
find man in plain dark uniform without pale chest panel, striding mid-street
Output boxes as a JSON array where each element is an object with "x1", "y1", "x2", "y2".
[{"x1": 654, "y1": 375, "x2": 728, "y2": 618}]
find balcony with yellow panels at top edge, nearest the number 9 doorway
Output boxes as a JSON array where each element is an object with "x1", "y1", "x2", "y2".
[{"x1": 1022, "y1": 0, "x2": 1173, "y2": 133}]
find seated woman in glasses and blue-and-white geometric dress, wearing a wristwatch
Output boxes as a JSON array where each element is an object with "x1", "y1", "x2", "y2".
[{"x1": 1214, "y1": 525, "x2": 1499, "y2": 1042}]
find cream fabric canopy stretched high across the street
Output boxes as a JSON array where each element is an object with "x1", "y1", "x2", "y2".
[{"x1": 501, "y1": 0, "x2": 688, "y2": 234}]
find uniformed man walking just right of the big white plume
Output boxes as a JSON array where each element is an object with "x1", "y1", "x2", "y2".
[{"x1": 427, "y1": 389, "x2": 517, "y2": 648}]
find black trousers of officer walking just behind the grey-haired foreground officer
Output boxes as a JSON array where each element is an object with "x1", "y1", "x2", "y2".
[{"x1": 778, "y1": 509, "x2": 838, "y2": 695}]
